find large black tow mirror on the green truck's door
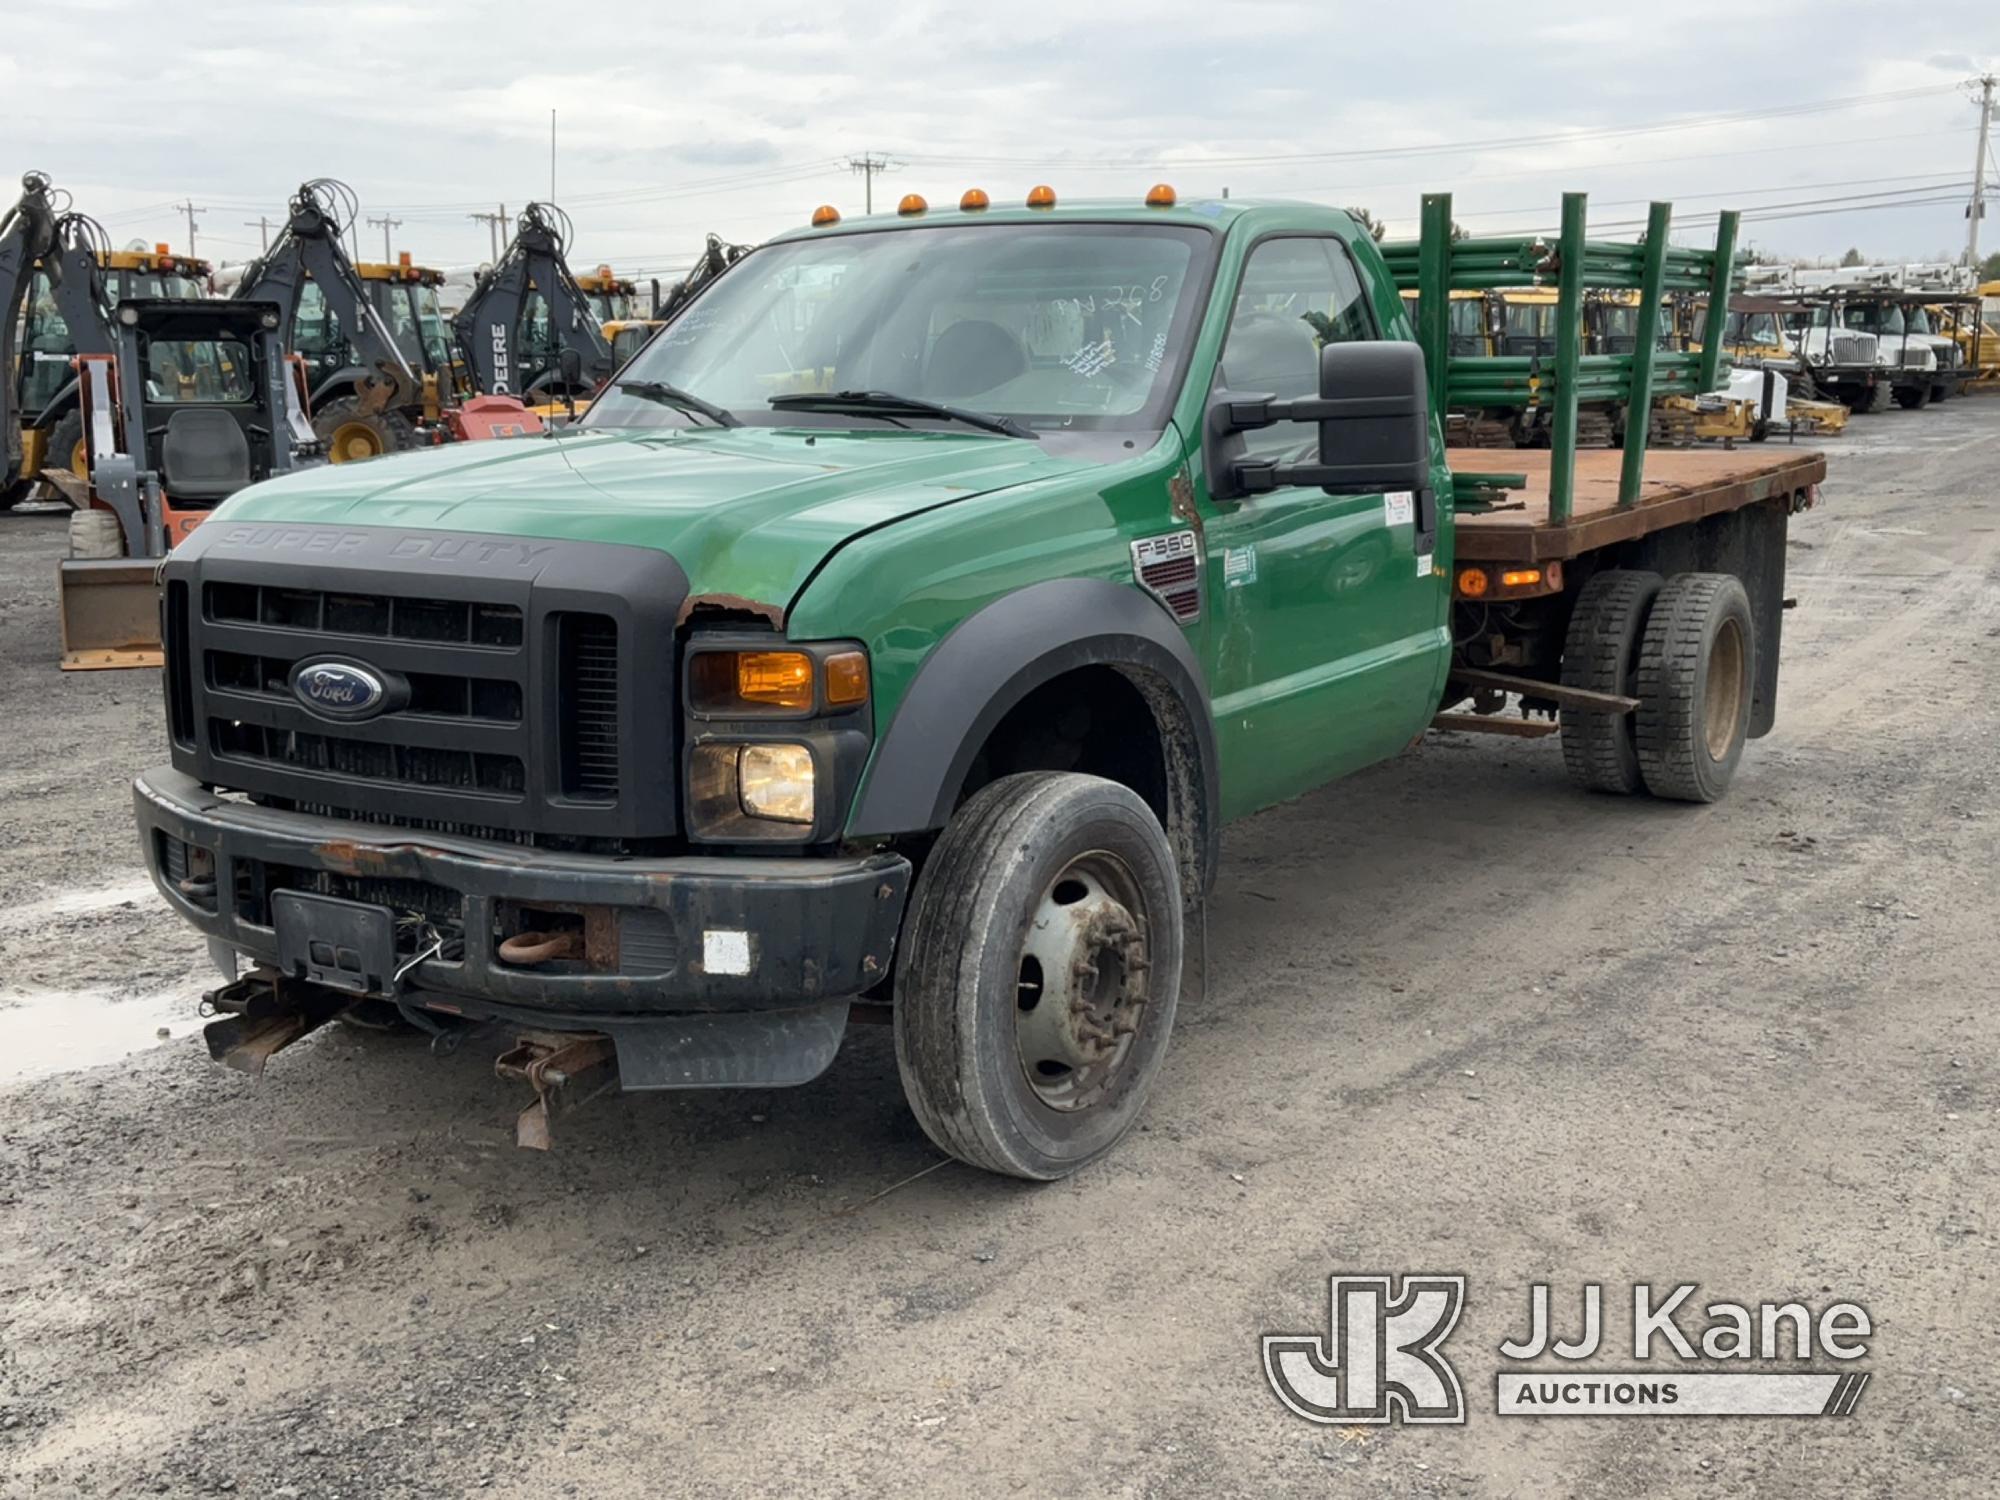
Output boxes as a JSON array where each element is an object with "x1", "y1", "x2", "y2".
[{"x1": 1204, "y1": 342, "x2": 1430, "y2": 500}]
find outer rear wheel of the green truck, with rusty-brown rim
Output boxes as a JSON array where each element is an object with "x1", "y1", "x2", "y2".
[{"x1": 1634, "y1": 572, "x2": 1756, "y2": 802}]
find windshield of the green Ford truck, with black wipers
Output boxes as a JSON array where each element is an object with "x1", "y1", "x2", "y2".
[{"x1": 586, "y1": 224, "x2": 1212, "y2": 432}]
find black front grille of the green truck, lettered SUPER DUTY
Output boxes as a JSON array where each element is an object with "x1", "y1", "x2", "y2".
[{"x1": 166, "y1": 522, "x2": 688, "y2": 848}]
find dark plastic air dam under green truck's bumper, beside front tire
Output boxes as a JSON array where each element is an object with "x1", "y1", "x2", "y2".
[{"x1": 602, "y1": 1000, "x2": 848, "y2": 1090}]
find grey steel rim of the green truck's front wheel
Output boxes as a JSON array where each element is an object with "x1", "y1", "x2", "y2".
[{"x1": 1014, "y1": 850, "x2": 1150, "y2": 1114}]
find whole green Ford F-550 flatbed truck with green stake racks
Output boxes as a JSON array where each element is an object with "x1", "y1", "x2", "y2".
[{"x1": 136, "y1": 188, "x2": 1824, "y2": 1178}]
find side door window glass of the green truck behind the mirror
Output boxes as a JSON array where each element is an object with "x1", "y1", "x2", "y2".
[{"x1": 1220, "y1": 238, "x2": 1376, "y2": 458}]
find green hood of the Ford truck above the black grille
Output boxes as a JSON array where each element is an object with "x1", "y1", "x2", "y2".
[{"x1": 206, "y1": 428, "x2": 1086, "y2": 610}]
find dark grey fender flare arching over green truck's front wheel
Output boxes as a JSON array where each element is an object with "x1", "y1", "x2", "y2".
[{"x1": 848, "y1": 578, "x2": 1222, "y2": 904}]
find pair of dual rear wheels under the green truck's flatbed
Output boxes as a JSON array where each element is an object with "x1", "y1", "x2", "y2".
[{"x1": 1562, "y1": 568, "x2": 1756, "y2": 802}]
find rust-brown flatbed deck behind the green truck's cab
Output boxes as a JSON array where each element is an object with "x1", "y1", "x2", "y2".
[{"x1": 1450, "y1": 446, "x2": 1826, "y2": 562}]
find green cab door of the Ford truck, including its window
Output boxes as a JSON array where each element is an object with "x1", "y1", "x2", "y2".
[{"x1": 1190, "y1": 234, "x2": 1450, "y2": 818}]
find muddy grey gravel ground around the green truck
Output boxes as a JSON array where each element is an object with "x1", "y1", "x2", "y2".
[{"x1": 0, "y1": 398, "x2": 2000, "y2": 1500}]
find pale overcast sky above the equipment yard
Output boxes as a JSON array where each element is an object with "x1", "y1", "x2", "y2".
[{"x1": 0, "y1": 0, "x2": 2000, "y2": 274}]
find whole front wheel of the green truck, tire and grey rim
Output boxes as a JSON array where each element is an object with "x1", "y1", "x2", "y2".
[{"x1": 894, "y1": 772, "x2": 1182, "y2": 1182}]
